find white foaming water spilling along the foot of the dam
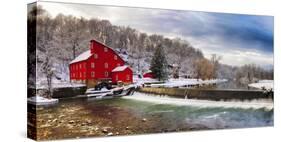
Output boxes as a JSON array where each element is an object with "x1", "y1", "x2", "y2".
[{"x1": 122, "y1": 92, "x2": 274, "y2": 110}]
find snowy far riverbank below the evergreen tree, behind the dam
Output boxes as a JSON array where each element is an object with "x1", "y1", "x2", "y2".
[{"x1": 151, "y1": 78, "x2": 227, "y2": 87}]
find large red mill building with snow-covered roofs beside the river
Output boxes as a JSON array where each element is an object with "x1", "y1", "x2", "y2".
[{"x1": 69, "y1": 40, "x2": 133, "y2": 87}]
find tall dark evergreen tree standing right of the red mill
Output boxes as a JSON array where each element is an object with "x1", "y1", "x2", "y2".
[{"x1": 150, "y1": 44, "x2": 168, "y2": 81}]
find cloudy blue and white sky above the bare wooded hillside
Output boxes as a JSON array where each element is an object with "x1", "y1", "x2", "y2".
[{"x1": 39, "y1": 2, "x2": 274, "y2": 68}]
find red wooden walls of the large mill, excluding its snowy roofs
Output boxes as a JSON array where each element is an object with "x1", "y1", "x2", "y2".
[{"x1": 69, "y1": 40, "x2": 133, "y2": 82}]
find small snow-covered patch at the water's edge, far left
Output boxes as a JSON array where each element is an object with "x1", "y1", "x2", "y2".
[{"x1": 27, "y1": 96, "x2": 59, "y2": 105}]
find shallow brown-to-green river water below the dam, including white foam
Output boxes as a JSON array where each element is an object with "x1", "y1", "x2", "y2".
[{"x1": 37, "y1": 92, "x2": 273, "y2": 140}]
